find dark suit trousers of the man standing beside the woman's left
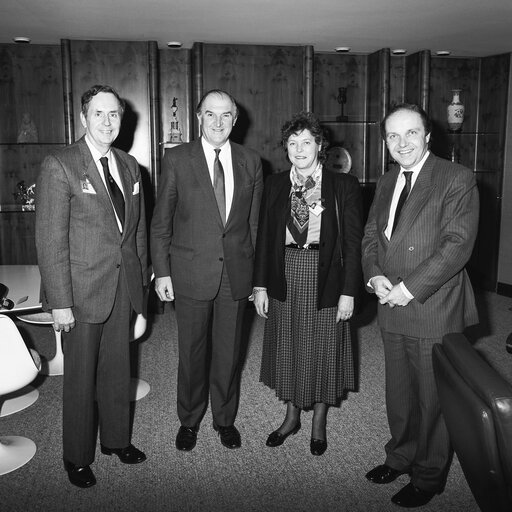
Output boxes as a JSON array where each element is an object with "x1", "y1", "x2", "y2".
[{"x1": 175, "y1": 267, "x2": 247, "y2": 427}]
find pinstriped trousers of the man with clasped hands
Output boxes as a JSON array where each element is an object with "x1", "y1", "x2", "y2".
[{"x1": 382, "y1": 331, "x2": 452, "y2": 492}]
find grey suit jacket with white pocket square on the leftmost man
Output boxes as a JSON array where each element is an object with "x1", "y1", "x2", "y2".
[{"x1": 36, "y1": 137, "x2": 147, "y2": 323}]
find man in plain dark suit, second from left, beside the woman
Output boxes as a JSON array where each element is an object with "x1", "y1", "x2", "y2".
[{"x1": 151, "y1": 90, "x2": 263, "y2": 451}]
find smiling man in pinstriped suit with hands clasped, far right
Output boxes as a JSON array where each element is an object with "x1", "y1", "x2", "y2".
[{"x1": 362, "y1": 104, "x2": 479, "y2": 507}]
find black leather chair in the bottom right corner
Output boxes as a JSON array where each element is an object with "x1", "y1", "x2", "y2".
[{"x1": 432, "y1": 334, "x2": 512, "y2": 512}]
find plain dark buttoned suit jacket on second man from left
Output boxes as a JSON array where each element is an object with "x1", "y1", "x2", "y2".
[{"x1": 151, "y1": 140, "x2": 263, "y2": 300}]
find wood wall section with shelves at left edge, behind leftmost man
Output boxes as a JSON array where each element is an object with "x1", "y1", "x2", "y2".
[{"x1": 0, "y1": 44, "x2": 65, "y2": 264}]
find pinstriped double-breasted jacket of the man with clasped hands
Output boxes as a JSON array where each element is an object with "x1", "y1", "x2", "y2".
[{"x1": 362, "y1": 154, "x2": 479, "y2": 338}]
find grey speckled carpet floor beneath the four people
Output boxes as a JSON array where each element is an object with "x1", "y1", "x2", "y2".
[{"x1": 0, "y1": 293, "x2": 512, "y2": 512}]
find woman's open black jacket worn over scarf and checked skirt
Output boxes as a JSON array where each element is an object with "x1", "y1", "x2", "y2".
[{"x1": 254, "y1": 169, "x2": 363, "y2": 309}]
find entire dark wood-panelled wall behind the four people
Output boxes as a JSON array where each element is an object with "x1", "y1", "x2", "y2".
[{"x1": 0, "y1": 40, "x2": 512, "y2": 289}]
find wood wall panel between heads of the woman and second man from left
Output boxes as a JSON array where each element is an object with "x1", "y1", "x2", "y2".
[{"x1": 196, "y1": 44, "x2": 305, "y2": 173}]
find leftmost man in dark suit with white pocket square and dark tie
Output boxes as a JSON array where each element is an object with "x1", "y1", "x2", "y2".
[{"x1": 36, "y1": 85, "x2": 147, "y2": 487}]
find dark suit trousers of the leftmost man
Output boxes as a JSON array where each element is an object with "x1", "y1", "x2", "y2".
[{"x1": 63, "y1": 269, "x2": 131, "y2": 466}]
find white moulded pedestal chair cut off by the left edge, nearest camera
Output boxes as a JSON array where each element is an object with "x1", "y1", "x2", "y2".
[{"x1": 0, "y1": 315, "x2": 40, "y2": 475}]
